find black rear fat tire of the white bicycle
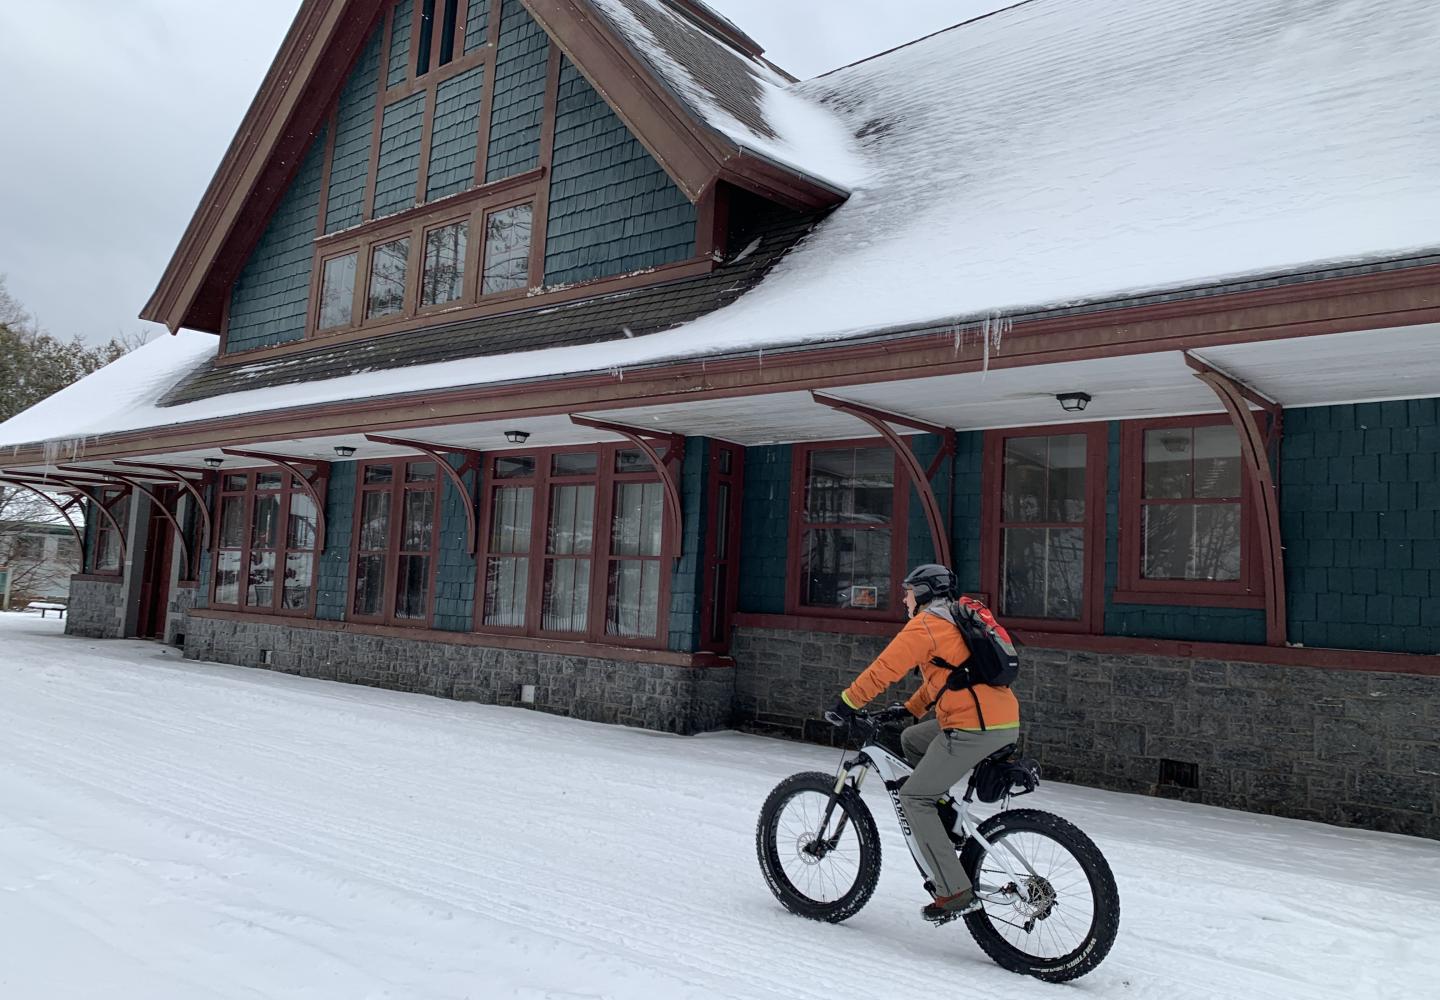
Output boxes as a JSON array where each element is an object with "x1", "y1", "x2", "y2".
[{"x1": 960, "y1": 808, "x2": 1120, "y2": 983}]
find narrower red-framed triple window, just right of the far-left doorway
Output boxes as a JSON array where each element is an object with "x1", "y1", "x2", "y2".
[{"x1": 210, "y1": 470, "x2": 320, "y2": 614}]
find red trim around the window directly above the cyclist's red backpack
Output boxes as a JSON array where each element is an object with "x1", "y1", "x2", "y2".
[{"x1": 981, "y1": 422, "x2": 1110, "y2": 634}]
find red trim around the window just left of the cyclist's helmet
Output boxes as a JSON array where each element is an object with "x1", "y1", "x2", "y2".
[{"x1": 785, "y1": 438, "x2": 910, "y2": 622}]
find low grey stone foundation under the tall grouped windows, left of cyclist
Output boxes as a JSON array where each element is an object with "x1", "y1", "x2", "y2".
[{"x1": 184, "y1": 615, "x2": 734, "y2": 733}]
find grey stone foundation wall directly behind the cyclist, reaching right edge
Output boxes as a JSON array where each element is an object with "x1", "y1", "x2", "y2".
[{"x1": 732, "y1": 628, "x2": 1440, "y2": 839}]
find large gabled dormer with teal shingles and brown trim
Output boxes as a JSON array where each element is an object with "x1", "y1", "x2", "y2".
[{"x1": 143, "y1": 0, "x2": 845, "y2": 357}]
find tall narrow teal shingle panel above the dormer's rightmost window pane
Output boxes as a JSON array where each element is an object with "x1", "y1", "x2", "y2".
[{"x1": 485, "y1": 0, "x2": 550, "y2": 182}]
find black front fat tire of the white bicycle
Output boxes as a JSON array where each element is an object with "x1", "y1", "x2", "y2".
[{"x1": 755, "y1": 771, "x2": 880, "y2": 924}]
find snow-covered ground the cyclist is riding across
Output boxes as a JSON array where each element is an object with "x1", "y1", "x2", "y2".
[{"x1": 0, "y1": 614, "x2": 1440, "y2": 1000}]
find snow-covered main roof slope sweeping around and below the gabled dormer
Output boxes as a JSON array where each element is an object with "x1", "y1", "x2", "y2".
[{"x1": 0, "y1": 0, "x2": 1440, "y2": 445}]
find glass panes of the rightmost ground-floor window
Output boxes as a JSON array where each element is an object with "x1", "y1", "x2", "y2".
[{"x1": 1140, "y1": 424, "x2": 1241, "y2": 581}]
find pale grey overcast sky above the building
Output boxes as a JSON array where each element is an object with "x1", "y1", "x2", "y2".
[{"x1": 0, "y1": 0, "x2": 1012, "y2": 340}]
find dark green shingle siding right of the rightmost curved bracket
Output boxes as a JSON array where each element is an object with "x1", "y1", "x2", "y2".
[{"x1": 1280, "y1": 399, "x2": 1440, "y2": 653}]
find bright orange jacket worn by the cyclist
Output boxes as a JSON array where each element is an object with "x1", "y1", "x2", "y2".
[{"x1": 841, "y1": 608, "x2": 1020, "y2": 729}]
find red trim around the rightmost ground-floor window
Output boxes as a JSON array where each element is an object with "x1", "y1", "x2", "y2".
[{"x1": 1113, "y1": 414, "x2": 1264, "y2": 608}]
